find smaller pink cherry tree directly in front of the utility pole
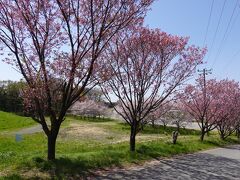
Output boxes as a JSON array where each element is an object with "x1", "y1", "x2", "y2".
[{"x1": 179, "y1": 77, "x2": 219, "y2": 141}]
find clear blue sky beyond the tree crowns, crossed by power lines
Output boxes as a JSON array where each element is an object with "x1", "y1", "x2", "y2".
[{"x1": 0, "y1": 0, "x2": 240, "y2": 81}]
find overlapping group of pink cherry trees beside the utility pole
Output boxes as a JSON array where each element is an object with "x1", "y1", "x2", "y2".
[{"x1": 179, "y1": 77, "x2": 240, "y2": 140}]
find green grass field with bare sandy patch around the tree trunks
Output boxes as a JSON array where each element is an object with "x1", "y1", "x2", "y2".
[{"x1": 0, "y1": 112, "x2": 237, "y2": 179}]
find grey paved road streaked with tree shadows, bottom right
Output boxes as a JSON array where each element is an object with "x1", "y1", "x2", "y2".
[{"x1": 91, "y1": 145, "x2": 240, "y2": 180}]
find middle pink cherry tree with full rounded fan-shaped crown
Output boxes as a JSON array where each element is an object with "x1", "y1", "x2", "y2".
[{"x1": 99, "y1": 28, "x2": 205, "y2": 151}]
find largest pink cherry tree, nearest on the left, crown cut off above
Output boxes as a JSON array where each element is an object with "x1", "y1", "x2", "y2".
[{"x1": 0, "y1": 0, "x2": 153, "y2": 160}]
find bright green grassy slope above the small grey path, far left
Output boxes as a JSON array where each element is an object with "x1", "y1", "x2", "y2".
[{"x1": 0, "y1": 111, "x2": 36, "y2": 132}]
